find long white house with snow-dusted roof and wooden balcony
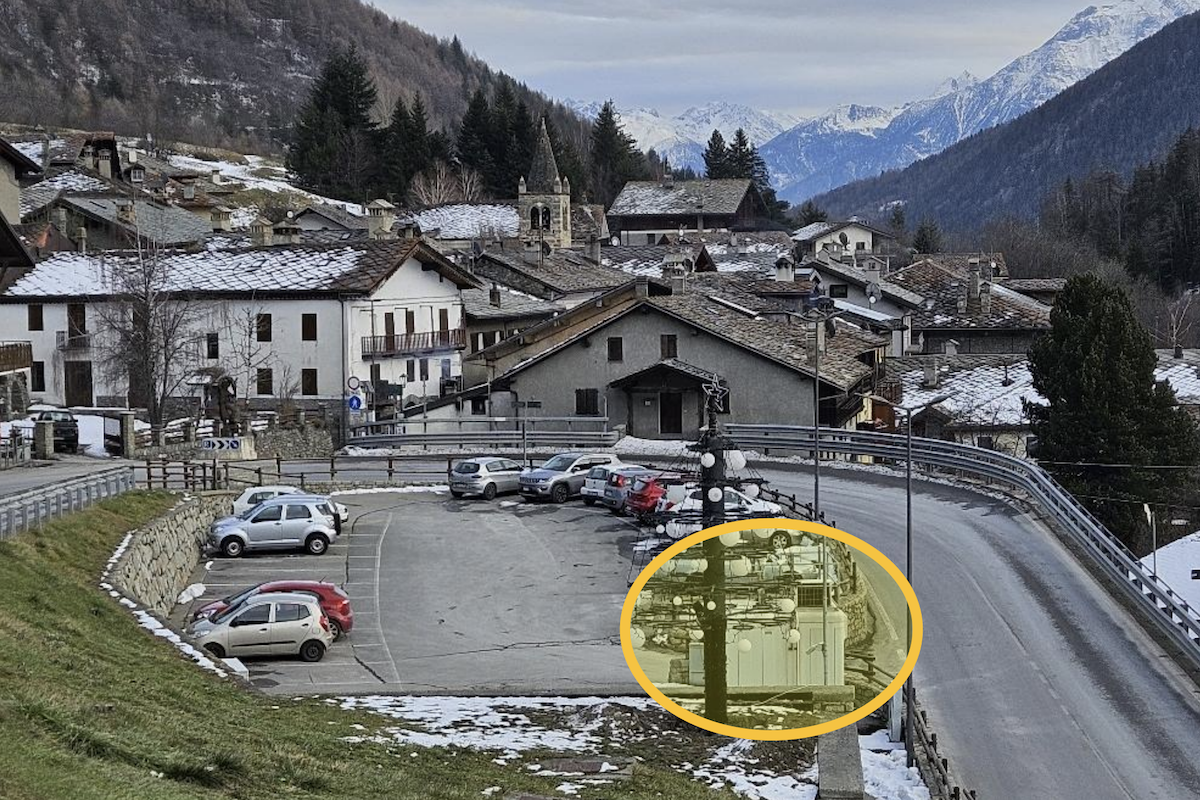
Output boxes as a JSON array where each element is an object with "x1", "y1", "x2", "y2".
[{"x1": 0, "y1": 240, "x2": 480, "y2": 408}]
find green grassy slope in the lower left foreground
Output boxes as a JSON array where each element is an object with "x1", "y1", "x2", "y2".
[{"x1": 0, "y1": 492, "x2": 748, "y2": 800}]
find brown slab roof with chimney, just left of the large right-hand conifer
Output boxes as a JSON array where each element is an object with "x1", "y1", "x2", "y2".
[{"x1": 887, "y1": 261, "x2": 1050, "y2": 330}]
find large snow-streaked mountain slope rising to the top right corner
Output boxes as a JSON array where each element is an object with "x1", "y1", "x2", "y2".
[{"x1": 761, "y1": 0, "x2": 1200, "y2": 203}]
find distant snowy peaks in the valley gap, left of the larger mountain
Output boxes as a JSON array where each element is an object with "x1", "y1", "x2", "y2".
[{"x1": 565, "y1": 100, "x2": 799, "y2": 172}]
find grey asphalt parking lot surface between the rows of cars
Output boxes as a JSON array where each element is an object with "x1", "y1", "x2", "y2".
[{"x1": 172, "y1": 492, "x2": 638, "y2": 694}]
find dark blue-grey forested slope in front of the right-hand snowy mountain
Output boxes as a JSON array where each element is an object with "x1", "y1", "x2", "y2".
[{"x1": 816, "y1": 14, "x2": 1200, "y2": 229}]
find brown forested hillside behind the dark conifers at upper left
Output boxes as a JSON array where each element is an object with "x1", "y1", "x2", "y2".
[{"x1": 0, "y1": 0, "x2": 587, "y2": 151}]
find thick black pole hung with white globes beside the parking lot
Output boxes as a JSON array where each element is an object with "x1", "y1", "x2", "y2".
[{"x1": 700, "y1": 380, "x2": 730, "y2": 724}]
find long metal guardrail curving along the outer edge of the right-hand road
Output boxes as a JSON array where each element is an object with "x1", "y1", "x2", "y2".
[{"x1": 726, "y1": 425, "x2": 1200, "y2": 666}]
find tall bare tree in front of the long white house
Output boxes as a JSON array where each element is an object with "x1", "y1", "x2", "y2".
[{"x1": 95, "y1": 245, "x2": 204, "y2": 426}]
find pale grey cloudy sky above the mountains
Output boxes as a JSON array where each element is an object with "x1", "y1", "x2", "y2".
[{"x1": 374, "y1": 0, "x2": 1087, "y2": 116}]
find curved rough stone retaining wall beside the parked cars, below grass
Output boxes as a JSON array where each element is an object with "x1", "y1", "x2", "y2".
[{"x1": 112, "y1": 492, "x2": 234, "y2": 615}]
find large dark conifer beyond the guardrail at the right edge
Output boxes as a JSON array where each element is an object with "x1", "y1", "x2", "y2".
[{"x1": 1026, "y1": 275, "x2": 1200, "y2": 555}]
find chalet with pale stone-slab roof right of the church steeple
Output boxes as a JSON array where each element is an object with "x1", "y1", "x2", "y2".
[{"x1": 608, "y1": 174, "x2": 767, "y2": 245}]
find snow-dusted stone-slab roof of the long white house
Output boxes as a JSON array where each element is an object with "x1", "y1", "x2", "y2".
[{"x1": 5, "y1": 241, "x2": 473, "y2": 297}]
